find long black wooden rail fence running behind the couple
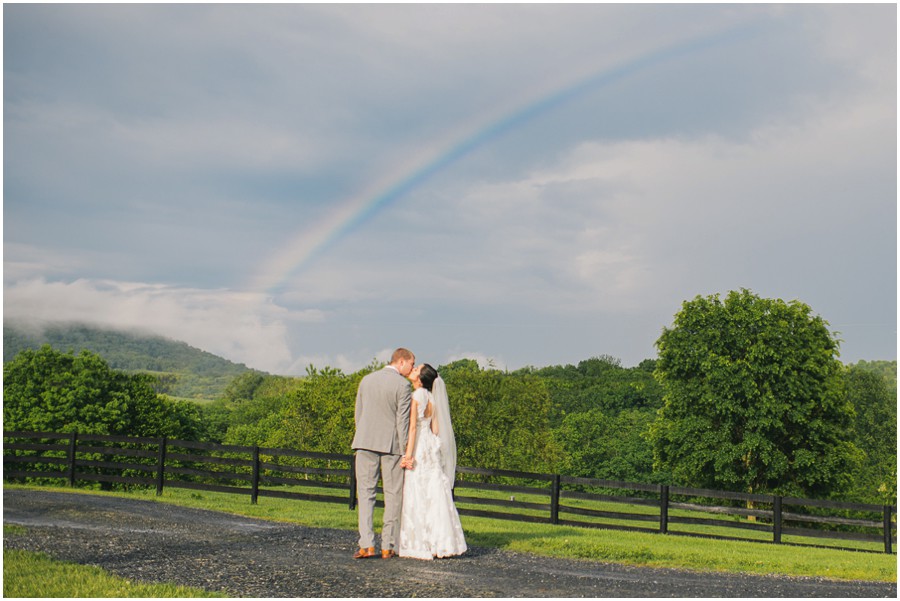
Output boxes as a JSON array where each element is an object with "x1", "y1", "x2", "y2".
[{"x1": 3, "y1": 432, "x2": 897, "y2": 553}]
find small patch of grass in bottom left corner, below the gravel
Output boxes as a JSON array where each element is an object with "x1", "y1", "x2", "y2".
[{"x1": 3, "y1": 544, "x2": 224, "y2": 598}]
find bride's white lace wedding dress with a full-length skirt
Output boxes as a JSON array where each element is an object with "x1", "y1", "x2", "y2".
[{"x1": 398, "y1": 388, "x2": 467, "y2": 559}]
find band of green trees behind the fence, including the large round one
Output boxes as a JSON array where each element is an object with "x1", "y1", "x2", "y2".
[{"x1": 4, "y1": 290, "x2": 897, "y2": 504}]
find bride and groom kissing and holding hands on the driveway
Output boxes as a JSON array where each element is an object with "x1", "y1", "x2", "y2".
[{"x1": 352, "y1": 348, "x2": 467, "y2": 559}]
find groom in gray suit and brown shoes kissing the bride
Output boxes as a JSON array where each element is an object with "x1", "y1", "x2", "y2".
[{"x1": 351, "y1": 348, "x2": 416, "y2": 559}]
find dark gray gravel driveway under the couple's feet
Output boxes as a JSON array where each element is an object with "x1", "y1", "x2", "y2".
[{"x1": 3, "y1": 490, "x2": 897, "y2": 598}]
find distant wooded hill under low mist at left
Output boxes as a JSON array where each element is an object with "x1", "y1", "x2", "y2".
[{"x1": 3, "y1": 321, "x2": 255, "y2": 400}]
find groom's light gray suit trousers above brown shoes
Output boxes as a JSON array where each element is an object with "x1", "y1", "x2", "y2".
[{"x1": 356, "y1": 449, "x2": 403, "y2": 551}]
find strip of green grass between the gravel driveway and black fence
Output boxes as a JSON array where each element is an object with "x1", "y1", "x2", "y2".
[{"x1": 6, "y1": 486, "x2": 897, "y2": 582}]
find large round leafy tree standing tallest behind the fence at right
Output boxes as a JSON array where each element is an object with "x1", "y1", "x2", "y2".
[{"x1": 651, "y1": 290, "x2": 859, "y2": 496}]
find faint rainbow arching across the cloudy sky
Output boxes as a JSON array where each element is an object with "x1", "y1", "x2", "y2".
[{"x1": 250, "y1": 25, "x2": 756, "y2": 293}]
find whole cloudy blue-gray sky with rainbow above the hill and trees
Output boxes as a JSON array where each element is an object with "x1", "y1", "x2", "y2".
[{"x1": 3, "y1": 3, "x2": 897, "y2": 375}]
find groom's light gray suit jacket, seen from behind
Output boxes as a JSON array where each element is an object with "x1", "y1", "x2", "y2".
[{"x1": 351, "y1": 367, "x2": 412, "y2": 455}]
